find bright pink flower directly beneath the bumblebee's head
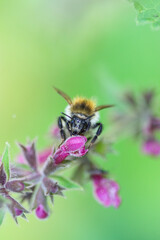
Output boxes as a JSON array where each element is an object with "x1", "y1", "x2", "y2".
[{"x1": 53, "y1": 136, "x2": 88, "y2": 164}]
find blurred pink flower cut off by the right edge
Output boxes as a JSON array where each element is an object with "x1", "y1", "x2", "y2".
[{"x1": 142, "y1": 139, "x2": 160, "y2": 156}]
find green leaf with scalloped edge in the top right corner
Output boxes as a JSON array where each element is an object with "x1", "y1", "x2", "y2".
[{"x1": 129, "y1": 0, "x2": 160, "y2": 29}]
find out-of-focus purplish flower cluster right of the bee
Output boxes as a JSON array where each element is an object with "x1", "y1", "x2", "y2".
[{"x1": 113, "y1": 90, "x2": 160, "y2": 156}]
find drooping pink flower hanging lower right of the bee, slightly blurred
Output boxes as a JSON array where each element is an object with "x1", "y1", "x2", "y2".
[{"x1": 92, "y1": 175, "x2": 121, "y2": 208}]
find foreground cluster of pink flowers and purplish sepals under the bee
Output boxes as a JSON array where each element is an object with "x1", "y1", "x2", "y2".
[{"x1": 0, "y1": 128, "x2": 121, "y2": 222}]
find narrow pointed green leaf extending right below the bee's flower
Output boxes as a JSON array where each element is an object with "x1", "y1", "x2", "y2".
[{"x1": 52, "y1": 175, "x2": 82, "y2": 190}]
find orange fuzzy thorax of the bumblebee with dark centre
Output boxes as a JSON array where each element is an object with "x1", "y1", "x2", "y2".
[{"x1": 71, "y1": 97, "x2": 96, "y2": 116}]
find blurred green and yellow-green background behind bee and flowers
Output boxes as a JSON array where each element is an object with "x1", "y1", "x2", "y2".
[{"x1": 0, "y1": 0, "x2": 160, "y2": 240}]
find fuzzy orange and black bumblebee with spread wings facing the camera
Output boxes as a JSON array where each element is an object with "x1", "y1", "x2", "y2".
[{"x1": 54, "y1": 87, "x2": 113, "y2": 147}]
